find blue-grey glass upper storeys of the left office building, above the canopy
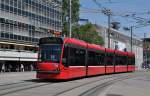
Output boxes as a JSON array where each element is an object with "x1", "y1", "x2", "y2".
[{"x1": 0, "y1": 0, "x2": 61, "y2": 43}]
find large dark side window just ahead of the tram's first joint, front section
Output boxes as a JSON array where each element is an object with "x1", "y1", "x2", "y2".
[{"x1": 68, "y1": 47, "x2": 86, "y2": 66}]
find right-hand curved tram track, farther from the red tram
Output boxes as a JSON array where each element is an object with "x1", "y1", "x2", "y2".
[{"x1": 53, "y1": 75, "x2": 133, "y2": 96}]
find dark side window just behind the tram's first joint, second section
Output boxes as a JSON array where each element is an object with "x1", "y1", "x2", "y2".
[{"x1": 88, "y1": 51, "x2": 100, "y2": 66}]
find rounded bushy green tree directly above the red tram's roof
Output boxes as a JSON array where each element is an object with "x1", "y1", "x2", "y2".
[{"x1": 73, "y1": 23, "x2": 104, "y2": 45}]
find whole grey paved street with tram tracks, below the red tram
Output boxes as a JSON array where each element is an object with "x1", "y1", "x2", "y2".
[{"x1": 0, "y1": 71, "x2": 150, "y2": 96}]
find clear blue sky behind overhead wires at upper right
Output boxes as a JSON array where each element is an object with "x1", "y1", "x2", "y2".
[{"x1": 80, "y1": 0, "x2": 150, "y2": 38}]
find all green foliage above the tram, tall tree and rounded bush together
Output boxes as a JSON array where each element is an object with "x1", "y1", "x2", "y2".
[{"x1": 62, "y1": 0, "x2": 104, "y2": 45}]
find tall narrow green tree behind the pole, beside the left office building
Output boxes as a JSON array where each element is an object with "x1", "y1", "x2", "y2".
[{"x1": 62, "y1": 0, "x2": 80, "y2": 36}]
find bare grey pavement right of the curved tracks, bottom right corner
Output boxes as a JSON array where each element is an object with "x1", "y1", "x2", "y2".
[{"x1": 99, "y1": 72, "x2": 150, "y2": 96}]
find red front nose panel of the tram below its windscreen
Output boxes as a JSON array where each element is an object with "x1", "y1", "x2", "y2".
[{"x1": 38, "y1": 62, "x2": 58, "y2": 71}]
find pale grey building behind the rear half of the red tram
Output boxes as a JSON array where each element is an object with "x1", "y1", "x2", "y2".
[{"x1": 97, "y1": 26, "x2": 143, "y2": 70}]
